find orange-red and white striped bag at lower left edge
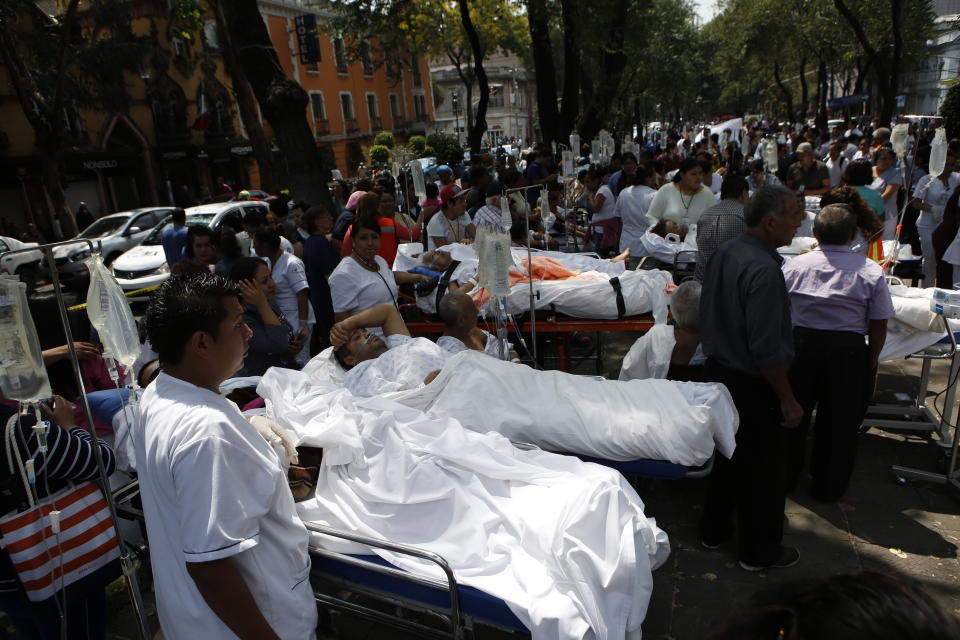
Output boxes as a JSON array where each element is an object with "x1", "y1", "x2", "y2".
[{"x1": 0, "y1": 482, "x2": 120, "y2": 602}]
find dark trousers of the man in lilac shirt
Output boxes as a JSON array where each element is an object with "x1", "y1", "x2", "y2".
[{"x1": 786, "y1": 327, "x2": 871, "y2": 502}]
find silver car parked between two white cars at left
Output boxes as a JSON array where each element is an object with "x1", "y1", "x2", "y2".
[{"x1": 42, "y1": 207, "x2": 174, "y2": 289}]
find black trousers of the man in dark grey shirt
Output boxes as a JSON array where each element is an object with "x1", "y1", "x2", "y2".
[{"x1": 700, "y1": 360, "x2": 786, "y2": 565}]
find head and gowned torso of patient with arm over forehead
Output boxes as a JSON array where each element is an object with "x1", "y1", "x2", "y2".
[{"x1": 330, "y1": 304, "x2": 446, "y2": 397}]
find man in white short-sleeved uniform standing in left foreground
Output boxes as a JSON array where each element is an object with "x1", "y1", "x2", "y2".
[{"x1": 134, "y1": 274, "x2": 317, "y2": 640}]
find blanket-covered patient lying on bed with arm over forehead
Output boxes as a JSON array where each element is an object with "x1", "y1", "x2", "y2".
[{"x1": 322, "y1": 305, "x2": 738, "y2": 466}]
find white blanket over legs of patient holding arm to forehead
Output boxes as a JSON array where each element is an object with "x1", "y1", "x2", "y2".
[{"x1": 389, "y1": 352, "x2": 739, "y2": 466}]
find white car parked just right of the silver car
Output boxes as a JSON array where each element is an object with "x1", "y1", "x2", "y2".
[{"x1": 111, "y1": 200, "x2": 270, "y2": 291}]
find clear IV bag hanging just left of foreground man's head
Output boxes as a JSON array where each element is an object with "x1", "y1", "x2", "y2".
[{"x1": 86, "y1": 255, "x2": 140, "y2": 376}]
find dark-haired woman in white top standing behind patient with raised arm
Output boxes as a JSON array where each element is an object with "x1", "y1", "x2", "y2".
[{"x1": 329, "y1": 216, "x2": 429, "y2": 322}]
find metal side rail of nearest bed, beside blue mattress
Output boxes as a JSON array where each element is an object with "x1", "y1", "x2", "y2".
[{"x1": 303, "y1": 521, "x2": 465, "y2": 640}]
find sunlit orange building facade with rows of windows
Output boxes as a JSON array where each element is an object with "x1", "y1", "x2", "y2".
[{"x1": 259, "y1": 0, "x2": 433, "y2": 176}]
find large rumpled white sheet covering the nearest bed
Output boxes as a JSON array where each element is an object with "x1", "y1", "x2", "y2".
[{"x1": 258, "y1": 368, "x2": 669, "y2": 640}]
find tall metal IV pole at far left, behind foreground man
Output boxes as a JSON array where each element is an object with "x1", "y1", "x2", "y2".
[{"x1": 0, "y1": 239, "x2": 151, "y2": 640}]
